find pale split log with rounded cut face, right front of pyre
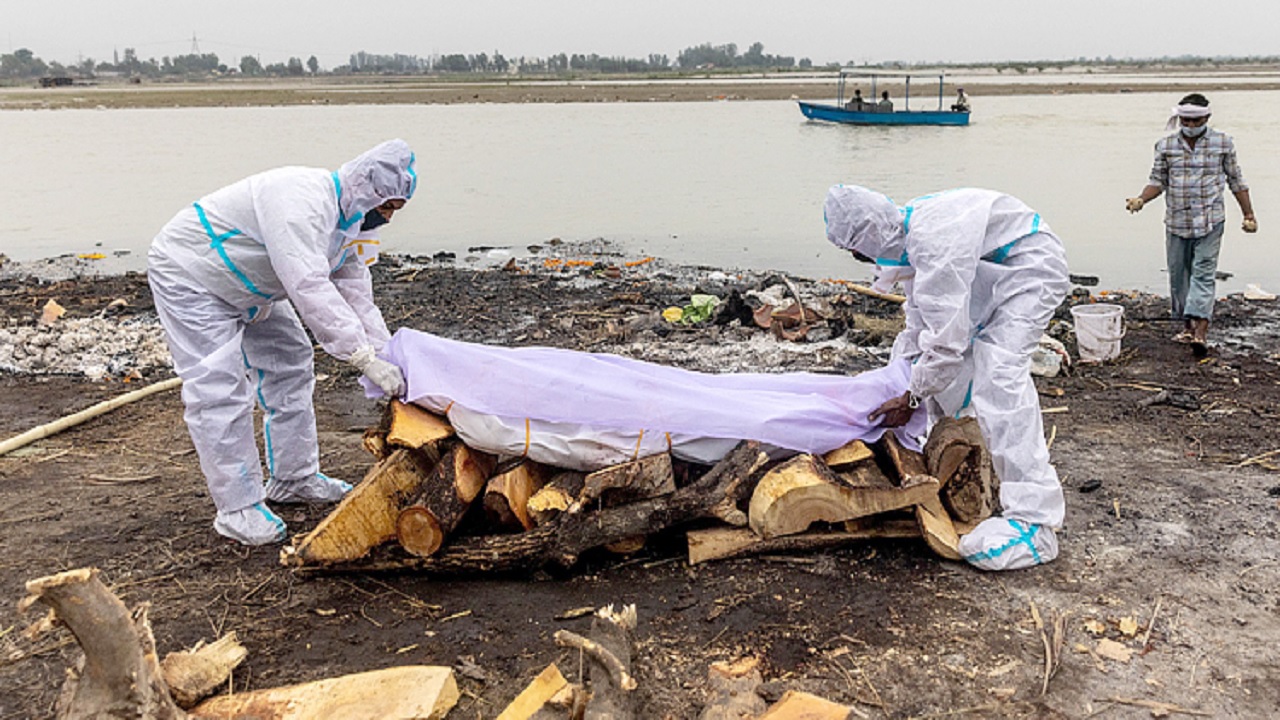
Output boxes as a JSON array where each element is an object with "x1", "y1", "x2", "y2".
[{"x1": 750, "y1": 455, "x2": 938, "y2": 539}]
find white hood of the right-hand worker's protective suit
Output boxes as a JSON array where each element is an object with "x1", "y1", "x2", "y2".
[{"x1": 823, "y1": 184, "x2": 906, "y2": 265}]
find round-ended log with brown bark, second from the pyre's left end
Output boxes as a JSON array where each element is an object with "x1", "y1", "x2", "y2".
[{"x1": 396, "y1": 443, "x2": 497, "y2": 557}]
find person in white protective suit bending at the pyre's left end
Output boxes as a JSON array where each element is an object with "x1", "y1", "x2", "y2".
[{"x1": 147, "y1": 140, "x2": 417, "y2": 544}]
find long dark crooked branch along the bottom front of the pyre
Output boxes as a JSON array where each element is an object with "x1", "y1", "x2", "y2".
[{"x1": 303, "y1": 442, "x2": 768, "y2": 573}]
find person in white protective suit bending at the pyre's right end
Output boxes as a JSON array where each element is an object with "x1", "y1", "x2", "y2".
[{"x1": 824, "y1": 186, "x2": 1069, "y2": 570}]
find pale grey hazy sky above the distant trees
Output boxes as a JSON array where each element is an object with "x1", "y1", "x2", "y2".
[{"x1": 10, "y1": 0, "x2": 1280, "y2": 68}]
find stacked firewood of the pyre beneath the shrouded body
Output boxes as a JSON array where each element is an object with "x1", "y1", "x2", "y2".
[{"x1": 282, "y1": 401, "x2": 997, "y2": 573}]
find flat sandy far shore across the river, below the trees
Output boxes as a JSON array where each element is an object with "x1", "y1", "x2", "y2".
[{"x1": 0, "y1": 70, "x2": 1280, "y2": 110}]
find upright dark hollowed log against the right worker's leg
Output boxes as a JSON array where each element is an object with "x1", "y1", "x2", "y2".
[{"x1": 924, "y1": 418, "x2": 1000, "y2": 532}]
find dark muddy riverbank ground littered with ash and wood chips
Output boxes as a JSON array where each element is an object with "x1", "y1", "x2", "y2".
[{"x1": 0, "y1": 249, "x2": 1280, "y2": 720}]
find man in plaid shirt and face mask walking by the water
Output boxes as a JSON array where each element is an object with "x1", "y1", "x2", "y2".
[{"x1": 1125, "y1": 92, "x2": 1258, "y2": 357}]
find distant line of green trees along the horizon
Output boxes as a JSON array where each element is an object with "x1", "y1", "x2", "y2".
[{"x1": 0, "y1": 42, "x2": 1280, "y2": 79}]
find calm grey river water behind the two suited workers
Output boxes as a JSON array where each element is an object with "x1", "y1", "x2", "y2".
[{"x1": 0, "y1": 90, "x2": 1280, "y2": 292}]
